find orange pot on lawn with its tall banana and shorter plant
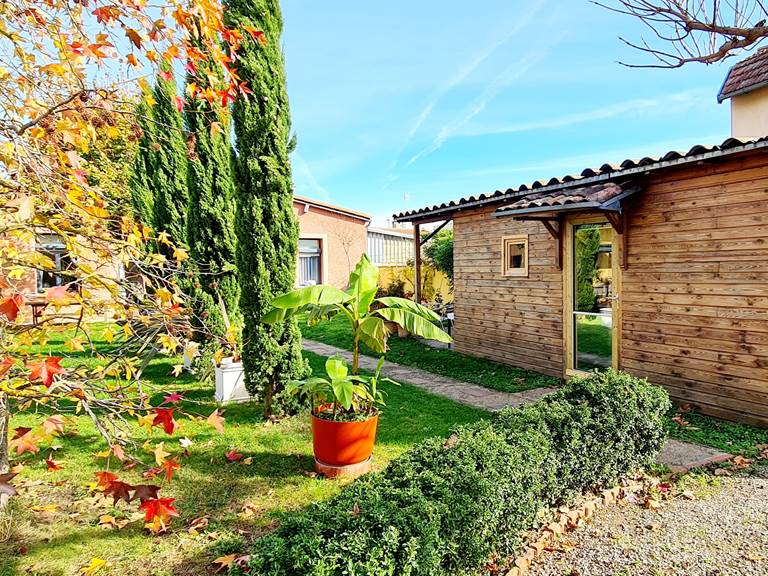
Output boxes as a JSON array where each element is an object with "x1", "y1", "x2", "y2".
[{"x1": 262, "y1": 254, "x2": 451, "y2": 474}]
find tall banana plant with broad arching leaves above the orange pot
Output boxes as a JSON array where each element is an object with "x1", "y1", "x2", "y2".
[{"x1": 262, "y1": 254, "x2": 451, "y2": 374}]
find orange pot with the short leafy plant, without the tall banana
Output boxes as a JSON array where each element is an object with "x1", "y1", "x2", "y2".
[{"x1": 288, "y1": 356, "x2": 396, "y2": 469}]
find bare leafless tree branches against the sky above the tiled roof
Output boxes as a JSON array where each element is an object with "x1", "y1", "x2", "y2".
[{"x1": 595, "y1": 0, "x2": 768, "y2": 68}]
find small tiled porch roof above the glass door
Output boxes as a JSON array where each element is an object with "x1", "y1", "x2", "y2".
[{"x1": 494, "y1": 182, "x2": 639, "y2": 217}]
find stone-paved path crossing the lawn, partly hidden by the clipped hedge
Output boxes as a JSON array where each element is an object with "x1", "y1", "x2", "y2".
[{"x1": 304, "y1": 340, "x2": 731, "y2": 472}]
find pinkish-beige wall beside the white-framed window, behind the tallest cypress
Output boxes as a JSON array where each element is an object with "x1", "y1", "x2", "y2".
[{"x1": 293, "y1": 199, "x2": 368, "y2": 288}]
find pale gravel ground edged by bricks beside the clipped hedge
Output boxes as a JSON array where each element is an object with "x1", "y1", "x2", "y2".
[{"x1": 529, "y1": 469, "x2": 768, "y2": 576}]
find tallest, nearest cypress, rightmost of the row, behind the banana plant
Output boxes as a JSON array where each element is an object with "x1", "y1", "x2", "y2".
[{"x1": 225, "y1": 0, "x2": 308, "y2": 414}]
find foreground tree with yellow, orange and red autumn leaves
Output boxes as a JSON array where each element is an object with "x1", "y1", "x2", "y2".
[{"x1": 0, "y1": 0, "x2": 258, "y2": 532}]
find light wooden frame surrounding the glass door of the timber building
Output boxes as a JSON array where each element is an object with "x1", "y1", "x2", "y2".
[{"x1": 563, "y1": 214, "x2": 623, "y2": 378}]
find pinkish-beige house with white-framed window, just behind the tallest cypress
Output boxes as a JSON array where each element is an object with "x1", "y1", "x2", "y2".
[{"x1": 293, "y1": 196, "x2": 371, "y2": 288}]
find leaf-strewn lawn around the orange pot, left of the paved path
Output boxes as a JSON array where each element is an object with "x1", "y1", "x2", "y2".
[{"x1": 0, "y1": 326, "x2": 487, "y2": 576}]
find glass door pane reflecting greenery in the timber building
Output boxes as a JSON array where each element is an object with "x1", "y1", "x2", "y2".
[{"x1": 569, "y1": 221, "x2": 618, "y2": 371}]
